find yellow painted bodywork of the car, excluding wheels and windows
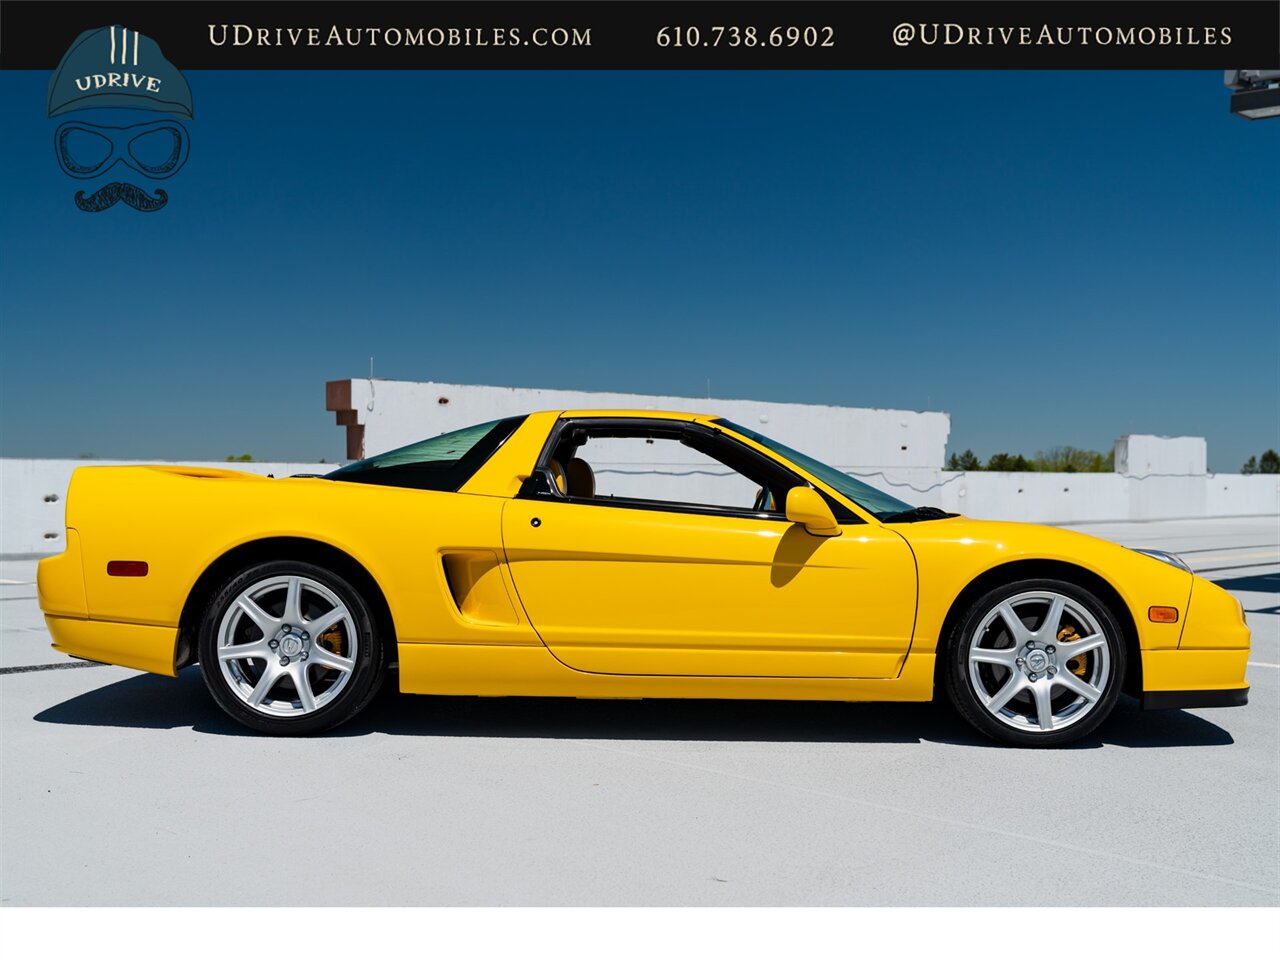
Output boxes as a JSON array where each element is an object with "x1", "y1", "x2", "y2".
[{"x1": 38, "y1": 411, "x2": 1249, "y2": 700}]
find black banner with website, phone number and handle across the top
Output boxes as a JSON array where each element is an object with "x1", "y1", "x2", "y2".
[{"x1": 0, "y1": 0, "x2": 1280, "y2": 70}]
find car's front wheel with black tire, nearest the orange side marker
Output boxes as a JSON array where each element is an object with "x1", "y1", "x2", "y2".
[{"x1": 942, "y1": 580, "x2": 1126, "y2": 746}]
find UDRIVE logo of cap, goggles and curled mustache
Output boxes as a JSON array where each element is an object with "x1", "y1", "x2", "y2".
[{"x1": 49, "y1": 26, "x2": 195, "y2": 214}]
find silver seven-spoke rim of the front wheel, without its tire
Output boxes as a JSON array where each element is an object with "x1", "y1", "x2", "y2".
[{"x1": 969, "y1": 590, "x2": 1111, "y2": 732}]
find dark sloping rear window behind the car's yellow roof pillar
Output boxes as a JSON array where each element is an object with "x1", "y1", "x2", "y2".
[{"x1": 325, "y1": 417, "x2": 525, "y2": 490}]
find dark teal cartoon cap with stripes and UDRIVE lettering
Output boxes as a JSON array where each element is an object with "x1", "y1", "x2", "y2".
[{"x1": 49, "y1": 27, "x2": 195, "y2": 120}]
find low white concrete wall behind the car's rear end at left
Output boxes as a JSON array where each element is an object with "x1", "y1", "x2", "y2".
[{"x1": 0, "y1": 460, "x2": 335, "y2": 557}]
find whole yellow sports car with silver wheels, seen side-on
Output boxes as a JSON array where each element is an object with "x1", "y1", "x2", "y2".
[{"x1": 38, "y1": 411, "x2": 1249, "y2": 746}]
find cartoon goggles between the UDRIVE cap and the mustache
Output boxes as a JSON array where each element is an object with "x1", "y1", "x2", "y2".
[{"x1": 54, "y1": 120, "x2": 191, "y2": 180}]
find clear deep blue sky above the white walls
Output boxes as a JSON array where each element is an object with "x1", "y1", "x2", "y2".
[{"x1": 0, "y1": 72, "x2": 1280, "y2": 471}]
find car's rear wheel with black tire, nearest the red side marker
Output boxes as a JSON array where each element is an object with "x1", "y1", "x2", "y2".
[{"x1": 200, "y1": 561, "x2": 387, "y2": 735}]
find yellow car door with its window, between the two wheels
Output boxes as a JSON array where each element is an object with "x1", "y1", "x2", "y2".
[{"x1": 502, "y1": 421, "x2": 916, "y2": 677}]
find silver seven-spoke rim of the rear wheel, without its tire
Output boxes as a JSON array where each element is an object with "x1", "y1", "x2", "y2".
[{"x1": 218, "y1": 576, "x2": 358, "y2": 717}]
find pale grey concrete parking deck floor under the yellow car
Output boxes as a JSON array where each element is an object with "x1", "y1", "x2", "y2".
[{"x1": 0, "y1": 517, "x2": 1280, "y2": 906}]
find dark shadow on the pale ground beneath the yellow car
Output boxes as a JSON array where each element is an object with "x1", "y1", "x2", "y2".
[{"x1": 35, "y1": 668, "x2": 1234, "y2": 749}]
